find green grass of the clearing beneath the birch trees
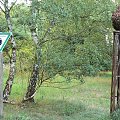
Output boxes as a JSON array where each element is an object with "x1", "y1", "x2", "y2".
[{"x1": 0, "y1": 73, "x2": 116, "y2": 120}]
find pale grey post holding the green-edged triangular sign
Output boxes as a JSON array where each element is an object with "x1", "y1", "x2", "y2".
[{"x1": 0, "y1": 52, "x2": 3, "y2": 118}]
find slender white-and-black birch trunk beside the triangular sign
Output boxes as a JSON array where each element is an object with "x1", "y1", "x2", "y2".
[{"x1": 3, "y1": 0, "x2": 16, "y2": 101}]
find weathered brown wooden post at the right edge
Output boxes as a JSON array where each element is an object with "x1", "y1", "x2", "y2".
[{"x1": 110, "y1": 31, "x2": 120, "y2": 113}]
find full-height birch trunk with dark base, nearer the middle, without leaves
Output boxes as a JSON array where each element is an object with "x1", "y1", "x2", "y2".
[{"x1": 23, "y1": 0, "x2": 41, "y2": 102}]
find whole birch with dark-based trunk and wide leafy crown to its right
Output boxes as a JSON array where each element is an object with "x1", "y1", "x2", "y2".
[{"x1": 23, "y1": 0, "x2": 115, "y2": 102}]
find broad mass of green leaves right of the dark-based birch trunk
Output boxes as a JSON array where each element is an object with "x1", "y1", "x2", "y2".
[{"x1": 36, "y1": 0, "x2": 114, "y2": 75}]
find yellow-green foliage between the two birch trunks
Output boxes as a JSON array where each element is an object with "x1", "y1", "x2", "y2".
[{"x1": 16, "y1": 39, "x2": 35, "y2": 73}]
